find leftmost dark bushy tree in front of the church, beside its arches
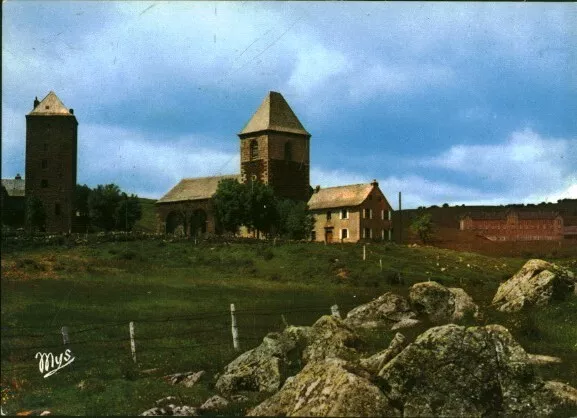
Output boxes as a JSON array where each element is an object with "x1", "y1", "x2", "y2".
[{"x1": 212, "y1": 179, "x2": 250, "y2": 234}]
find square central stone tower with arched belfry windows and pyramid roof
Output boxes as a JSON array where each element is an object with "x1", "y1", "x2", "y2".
[{"x1": 238, "y1": 91, "x2": 311, "y2": 202}]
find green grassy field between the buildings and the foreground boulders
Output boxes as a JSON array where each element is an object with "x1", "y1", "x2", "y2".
[{"x1": 1, "y1": 241, "x2": 577, "y2": 415}]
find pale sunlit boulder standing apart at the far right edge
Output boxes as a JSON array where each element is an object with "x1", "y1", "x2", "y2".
[{"x1": 493, "y1": 259, "x2": 577, "y2": 312}]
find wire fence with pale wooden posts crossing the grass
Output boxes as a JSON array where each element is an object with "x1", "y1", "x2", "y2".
[{"x1": 1, "y1": 306, "x2": 338, "y2": 374}]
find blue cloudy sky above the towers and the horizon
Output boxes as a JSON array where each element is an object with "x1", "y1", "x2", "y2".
[{"x1": 2, "y1": 0, "x2": 577, "y2": 208}]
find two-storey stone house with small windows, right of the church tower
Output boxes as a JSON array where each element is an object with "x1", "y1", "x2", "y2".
[{"x1": 308, "y1": 180, "x2": 392, "y2": 243}]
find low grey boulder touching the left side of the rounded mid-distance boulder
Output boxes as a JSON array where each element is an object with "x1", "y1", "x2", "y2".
[{"x1": 345, "y1": 292, "x2": 417, "y2": 328}]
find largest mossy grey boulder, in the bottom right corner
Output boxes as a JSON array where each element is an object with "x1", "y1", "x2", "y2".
[{"x1": 379, "y1": 324, "x2": 577, "y2": 416}]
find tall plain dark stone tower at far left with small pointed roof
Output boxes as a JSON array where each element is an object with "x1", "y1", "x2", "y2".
[{"x1": 26, "y1": 91, "x2": 78, "y2": 233}]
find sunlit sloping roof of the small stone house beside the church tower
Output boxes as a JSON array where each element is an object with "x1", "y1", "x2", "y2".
[{"x1": 308, "y1": 183, "x2": 373, "y2": 210}]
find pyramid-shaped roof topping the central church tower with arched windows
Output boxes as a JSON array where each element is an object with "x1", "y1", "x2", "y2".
[{"x1": 239, "y1": 91, "x2": 311, "y2": 136}]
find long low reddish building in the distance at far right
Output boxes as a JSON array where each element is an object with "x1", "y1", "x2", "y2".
[{"x1": 459, "y1": 210, "x2": 564, "y2": 241}]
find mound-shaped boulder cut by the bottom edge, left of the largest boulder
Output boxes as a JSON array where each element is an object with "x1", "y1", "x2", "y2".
[{"x1": 248, "y1": 358, "x2": 401, "y2": 417}]
